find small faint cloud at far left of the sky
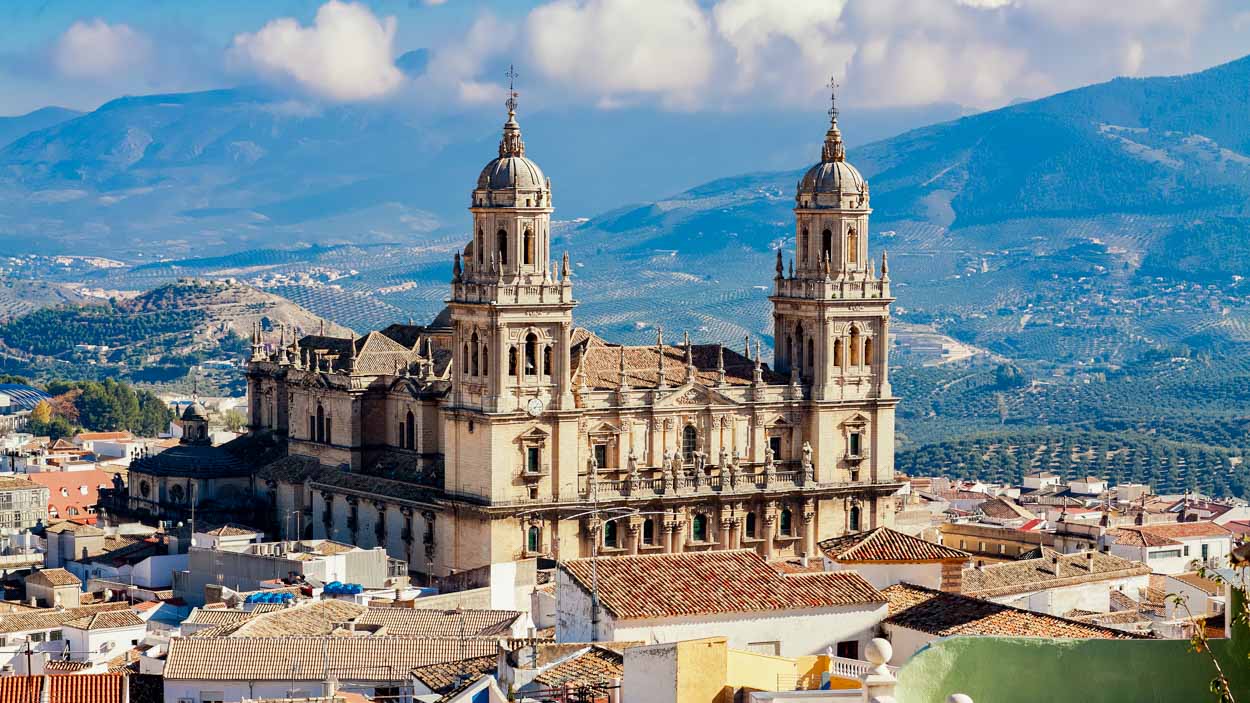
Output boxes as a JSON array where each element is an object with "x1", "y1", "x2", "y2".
[{"x1": 53, "y1": 19, "x2": 153, "y2": 78}]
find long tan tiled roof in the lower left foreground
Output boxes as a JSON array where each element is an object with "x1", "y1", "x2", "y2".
[{"x1": 164, "y1": 635, "x2": 499, "y2": 680}]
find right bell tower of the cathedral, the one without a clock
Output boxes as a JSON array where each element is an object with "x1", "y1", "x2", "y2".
[{"x1": 771, "y1": 81, "x2": 896, "y2": 482}]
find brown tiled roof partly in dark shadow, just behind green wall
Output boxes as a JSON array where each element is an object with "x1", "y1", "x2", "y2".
[{"x1": 883, "y1": 583, "x2": 1140, "y2": 639}]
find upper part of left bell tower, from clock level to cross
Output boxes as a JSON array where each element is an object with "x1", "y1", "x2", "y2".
[{"x1": 449, "y1": 75, "x2": 576, "y2": 413}]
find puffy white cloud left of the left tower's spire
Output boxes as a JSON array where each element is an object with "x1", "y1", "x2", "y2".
[{"x1": 229, "y1": 0, "x2": 404, "y2": 100}]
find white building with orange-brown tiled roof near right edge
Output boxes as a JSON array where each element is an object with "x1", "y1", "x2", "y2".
[{"x1": 1103, "y1": 523, "x2": 1233, "y2": 574}]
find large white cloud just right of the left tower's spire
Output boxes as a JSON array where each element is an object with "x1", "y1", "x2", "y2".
[{"x1": 526, "y1": 0, "x2": 714, "y2": 105}]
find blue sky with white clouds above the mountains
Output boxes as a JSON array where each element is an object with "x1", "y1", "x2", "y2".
[{"x1": 0, "y1": 0, "x2": 1250, "y2": 115}]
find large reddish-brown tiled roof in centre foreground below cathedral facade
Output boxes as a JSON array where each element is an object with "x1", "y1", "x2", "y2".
[{"x1": 560, "y1": 549, "x2": 885, "y2": 619}]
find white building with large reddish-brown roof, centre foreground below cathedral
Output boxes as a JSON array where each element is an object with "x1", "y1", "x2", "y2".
[{"x1": 556, "y1": 549, "x2": 885, "y2": 657}]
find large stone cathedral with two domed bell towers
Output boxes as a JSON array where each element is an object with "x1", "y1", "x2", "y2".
[{"x1": 235, "y1": 87, "x2": 900, "y2": 579}]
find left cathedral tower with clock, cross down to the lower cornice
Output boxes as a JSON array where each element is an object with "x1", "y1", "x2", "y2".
[{"x1": 443, "y1": 80, "x2": 578, "y2": 560}]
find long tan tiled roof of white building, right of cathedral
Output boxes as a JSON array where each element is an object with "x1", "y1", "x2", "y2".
[{"x1": 963, "y1": 547, "x2": 1150, "y2": 598}]
